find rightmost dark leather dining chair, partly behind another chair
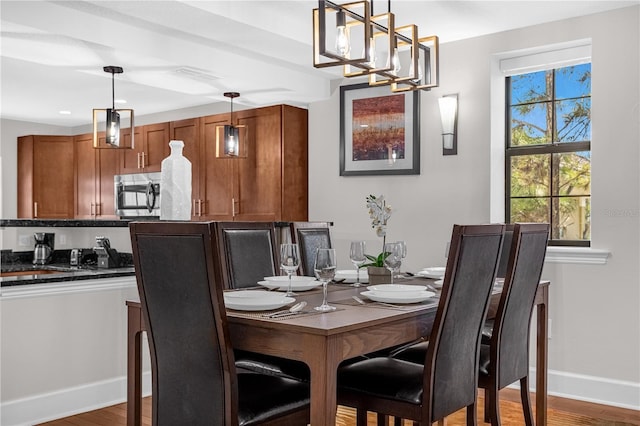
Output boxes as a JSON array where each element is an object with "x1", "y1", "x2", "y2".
[{"x1": 478, "y1": 223, "x2": 549, "y2": 426}]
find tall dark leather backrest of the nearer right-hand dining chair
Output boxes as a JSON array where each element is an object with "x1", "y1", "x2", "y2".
[{"x1": 423, "y1": 225, "x2": 504, "y2": 421}]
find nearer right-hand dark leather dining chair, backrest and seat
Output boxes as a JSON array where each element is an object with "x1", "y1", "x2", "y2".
[{"x1": 338, "y1": 225, "x2": 504, "y2": 426}]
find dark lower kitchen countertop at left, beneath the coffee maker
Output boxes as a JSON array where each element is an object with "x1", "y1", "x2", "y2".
[{"x1": 0, "y1": 264, "x2": 135, "y2": 287}]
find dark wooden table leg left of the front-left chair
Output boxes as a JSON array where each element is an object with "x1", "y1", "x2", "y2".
[{"x1": 127, "y1": 306, "x2": 142, "y2": 426}]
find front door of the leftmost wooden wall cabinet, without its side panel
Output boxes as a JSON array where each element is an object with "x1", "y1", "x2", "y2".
[{"x1": 33, "y1": 136, "x2": 74, "y2": 219}]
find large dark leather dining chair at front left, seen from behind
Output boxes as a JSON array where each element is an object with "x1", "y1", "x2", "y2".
[{"x1": 130, "y1": 221, "x2": 309, "y2": 426}]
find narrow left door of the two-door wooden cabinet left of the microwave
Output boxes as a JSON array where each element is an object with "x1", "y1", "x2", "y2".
[{"x1": 74, "y1": 133, "x2": 98, "y2": 219}]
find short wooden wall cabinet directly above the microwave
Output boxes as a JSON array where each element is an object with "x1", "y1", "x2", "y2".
[{"x1": 120, "y1": 123, "x2": 170, "y2": 174}]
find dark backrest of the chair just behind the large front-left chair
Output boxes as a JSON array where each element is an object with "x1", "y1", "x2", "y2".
[{"x1": 216, "y1": 222, "x2": 280, "y2": 289}]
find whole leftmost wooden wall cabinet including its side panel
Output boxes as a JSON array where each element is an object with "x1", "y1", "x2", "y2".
[{"x1": 18, "y1": 135, "x2": 74, "y2": 219}]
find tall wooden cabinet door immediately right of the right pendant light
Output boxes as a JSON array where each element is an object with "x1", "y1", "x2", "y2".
[{"x1": 234, "y1": 106, "x2": 282, "y2": 222}]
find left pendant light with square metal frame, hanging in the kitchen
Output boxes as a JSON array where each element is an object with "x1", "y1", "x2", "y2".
[{"x1": 93, "y1": 65, "x2": 135, "y2": 149}]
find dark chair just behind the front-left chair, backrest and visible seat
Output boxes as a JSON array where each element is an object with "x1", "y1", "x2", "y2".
[{"x1": 215, "y1": 222, "x2": 309, "y2": 381}]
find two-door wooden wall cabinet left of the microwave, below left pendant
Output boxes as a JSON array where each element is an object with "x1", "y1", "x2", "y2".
[{"x1": 74, "y1": 132, "x2": 120, "y2": 219}]
